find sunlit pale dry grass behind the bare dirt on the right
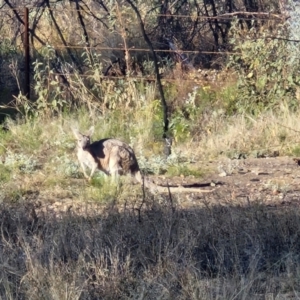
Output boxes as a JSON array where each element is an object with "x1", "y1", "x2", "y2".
[{"x1": 182, "y1": 105, "x2": 300, "y2": 158}]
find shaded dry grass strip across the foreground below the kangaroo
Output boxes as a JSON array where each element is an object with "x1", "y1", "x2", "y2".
[{"x1": 0, "y1": 198, "x2": 300, "y2": 299}]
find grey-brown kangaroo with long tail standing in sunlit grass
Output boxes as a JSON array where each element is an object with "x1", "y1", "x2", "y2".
[{"x1": 72, "y1": 126, "x2": 211, "y2": 192}]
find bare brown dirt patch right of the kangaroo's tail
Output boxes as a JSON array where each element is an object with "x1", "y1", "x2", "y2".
[{"x1": 152, "y1": 157, "x2": 300, "y2": 207}]
